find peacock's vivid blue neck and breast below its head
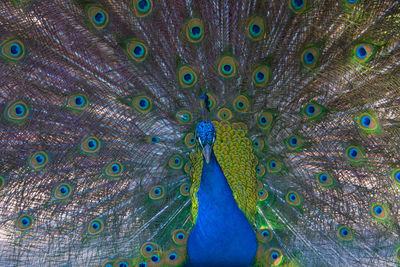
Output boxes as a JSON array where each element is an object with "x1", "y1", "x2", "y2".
[{"x1": 187, "y1": 152, "x2": 257, "y2": 266}]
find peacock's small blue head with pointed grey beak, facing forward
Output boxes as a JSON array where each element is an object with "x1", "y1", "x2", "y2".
[{"x1": 196, "y1": 121, "x2": 216, "y2": 163}]
